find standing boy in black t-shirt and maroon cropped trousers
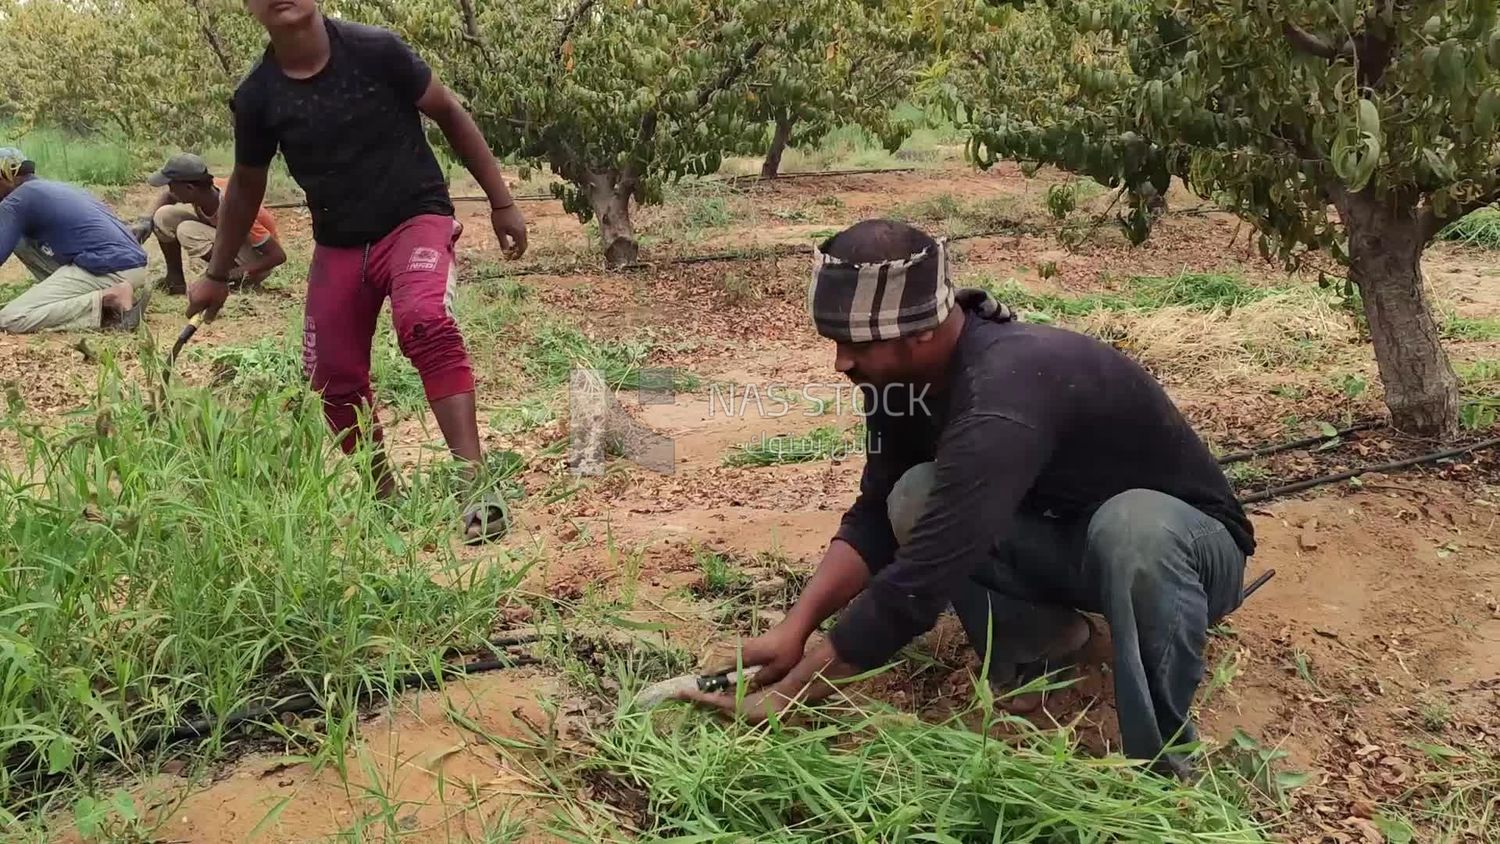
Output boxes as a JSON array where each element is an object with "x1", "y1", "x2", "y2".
[{"x1": 188, "y1": 0, "x2": 527, "y2": 541}]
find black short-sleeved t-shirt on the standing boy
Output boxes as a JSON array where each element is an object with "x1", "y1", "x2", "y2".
[{"x1": 231, "y1": 18, "x2": 453, "y2": 246}]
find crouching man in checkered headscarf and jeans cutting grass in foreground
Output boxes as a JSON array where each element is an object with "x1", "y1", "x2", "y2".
[{"x1": 690, "y1": 220, "x2": 1256, "y2": 774}]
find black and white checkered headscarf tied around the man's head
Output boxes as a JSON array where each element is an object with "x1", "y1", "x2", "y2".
[{"x1": 807, "y1": 233, "x2": 1013, "y2": 343}]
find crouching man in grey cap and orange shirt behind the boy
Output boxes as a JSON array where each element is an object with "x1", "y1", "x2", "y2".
[{"x1": 135, "y1": 153, "x2": 287, "y2": 295}]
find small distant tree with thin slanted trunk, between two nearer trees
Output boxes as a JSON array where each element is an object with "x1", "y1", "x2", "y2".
[{"x1": 744, "y1": 0, "x2": 938, "y2": 178}]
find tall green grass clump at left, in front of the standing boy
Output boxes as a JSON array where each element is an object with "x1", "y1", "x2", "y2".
[{"x1": 0, "y1": 361, "x2": 518, "y2": 826}]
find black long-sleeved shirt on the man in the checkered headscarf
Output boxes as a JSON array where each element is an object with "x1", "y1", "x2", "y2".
[{"x1": 833, "y1": 312, "x2": 1256, "y2": 669}]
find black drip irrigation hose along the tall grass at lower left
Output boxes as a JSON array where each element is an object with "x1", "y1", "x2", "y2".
[{"x1": 5, "y1": 633, "x2": 542, "y2": 784}]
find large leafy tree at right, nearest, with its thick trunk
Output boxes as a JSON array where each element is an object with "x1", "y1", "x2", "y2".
[{"x1": 959, "y1": 0, "x2": 1500, "y2": 438}]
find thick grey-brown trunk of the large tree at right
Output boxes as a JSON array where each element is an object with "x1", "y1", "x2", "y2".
[{"x1": 1340, "y1": 193, "x2": 1458, "y2": 439}]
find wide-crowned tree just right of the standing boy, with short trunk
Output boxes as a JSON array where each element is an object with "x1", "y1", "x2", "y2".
[{"x1": 364, "y1": 0, "x2": 833, "y2": 267}]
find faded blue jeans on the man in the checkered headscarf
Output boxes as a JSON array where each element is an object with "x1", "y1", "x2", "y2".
[{"x1": 887, "y1": 463, "x2": 1245, "y2": 771}]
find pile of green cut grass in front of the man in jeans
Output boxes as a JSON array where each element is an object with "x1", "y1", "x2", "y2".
[{"x1": 585, "y1": 692, "x2": 1265, "y2": 844}]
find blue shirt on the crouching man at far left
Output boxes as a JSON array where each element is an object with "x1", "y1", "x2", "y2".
[{"x1": 0, "y1": 178, "x2": 146, "y2": 276}]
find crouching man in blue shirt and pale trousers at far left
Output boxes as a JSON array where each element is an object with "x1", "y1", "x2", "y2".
[{"x1": 0, "y1": 148, "x2": 147, "y2": 334}]
